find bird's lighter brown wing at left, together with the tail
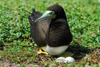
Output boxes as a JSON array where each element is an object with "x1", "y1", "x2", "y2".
[{"x1": 28, "y1": 9, "x2": 50, "y2": 47}]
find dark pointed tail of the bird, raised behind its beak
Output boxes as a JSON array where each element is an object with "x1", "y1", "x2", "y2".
[{"x1": 28, "y1": 8, "x2": 42, "y2": 25}]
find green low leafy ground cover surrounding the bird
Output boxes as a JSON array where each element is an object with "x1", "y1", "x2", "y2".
[{"x1": 0, "y1": 0, "x2": 100, "y2": 66}]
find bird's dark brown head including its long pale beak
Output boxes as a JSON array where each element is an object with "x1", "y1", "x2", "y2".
[{"x1": 36, "y1": 4, "x2": 66, "y2": 22}]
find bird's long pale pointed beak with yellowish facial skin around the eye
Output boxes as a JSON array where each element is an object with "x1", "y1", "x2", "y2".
[{"x1": 35, "y1": 11, "x2": 56, "y2": 22}]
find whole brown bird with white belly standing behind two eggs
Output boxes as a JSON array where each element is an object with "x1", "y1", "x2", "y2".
[{"x1": 28, "y1": 4, "x2": 73, "y2": 55}]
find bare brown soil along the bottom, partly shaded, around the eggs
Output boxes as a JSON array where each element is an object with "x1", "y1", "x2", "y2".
[{"x1": 0, "y1": 45, "x2": 100, "y2": 67}]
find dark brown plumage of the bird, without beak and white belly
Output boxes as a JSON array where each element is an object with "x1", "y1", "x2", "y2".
[{"x1": 28, "y1": 4, "x2": 72, "y2": 47}]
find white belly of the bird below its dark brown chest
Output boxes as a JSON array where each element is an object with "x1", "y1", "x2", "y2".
[{"x1": 45, "y1": 45, "x2": 68, "y2": 55}]
